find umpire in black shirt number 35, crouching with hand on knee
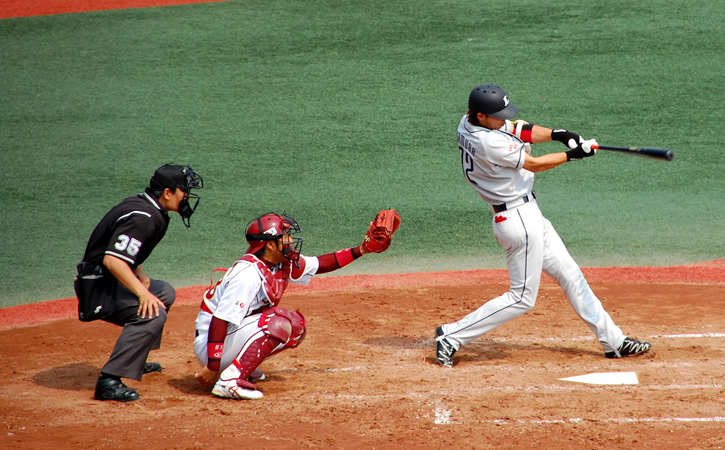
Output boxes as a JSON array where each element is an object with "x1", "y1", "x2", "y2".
[{"x1": 74, "y1": 164, "x2": 203, "y2": 402}]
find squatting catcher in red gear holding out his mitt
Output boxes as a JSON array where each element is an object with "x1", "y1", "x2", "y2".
[{"x1": 194, "y1": 209, "x2": 400, "y2": 399}]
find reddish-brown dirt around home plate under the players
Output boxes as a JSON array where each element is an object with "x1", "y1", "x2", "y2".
[{"x1": 0, "y1": 261, "x2": 725, "y2": 450}]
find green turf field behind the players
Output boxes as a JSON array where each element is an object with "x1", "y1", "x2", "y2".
[{"x1": 0, "y1": 0, "x2": 725, "y2": 307}]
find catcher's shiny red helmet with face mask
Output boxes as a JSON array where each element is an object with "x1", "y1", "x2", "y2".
[{"x1": 246, "y1": 211, "x2": 305, "y2": 263}]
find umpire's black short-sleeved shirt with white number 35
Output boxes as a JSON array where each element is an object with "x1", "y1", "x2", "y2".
[{"x1": 83, "y1": 189, "x2": 169, "y2": 269}]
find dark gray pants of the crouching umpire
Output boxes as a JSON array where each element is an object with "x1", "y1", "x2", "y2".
[{"x1": 101, "y1": 280, "x2": 176, "y2": 380}]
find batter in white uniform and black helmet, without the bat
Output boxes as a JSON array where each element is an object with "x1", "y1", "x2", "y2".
[{"x1": 436, "y1": 84, "x2": 651, "y2": 367}]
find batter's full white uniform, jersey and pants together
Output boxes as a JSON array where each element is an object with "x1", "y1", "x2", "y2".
[{"x1": 437, "y1": 115, "x2": 624, "y2": 352}]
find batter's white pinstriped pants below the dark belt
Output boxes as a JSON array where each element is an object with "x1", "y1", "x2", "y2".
[{"x1": 442, "y1": 200, "x2": 625, "y2": 352}]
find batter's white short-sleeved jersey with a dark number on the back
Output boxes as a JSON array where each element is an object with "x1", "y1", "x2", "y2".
[{"x1": 458, "y1": 115, "x2": 534, "y2": 204}]
